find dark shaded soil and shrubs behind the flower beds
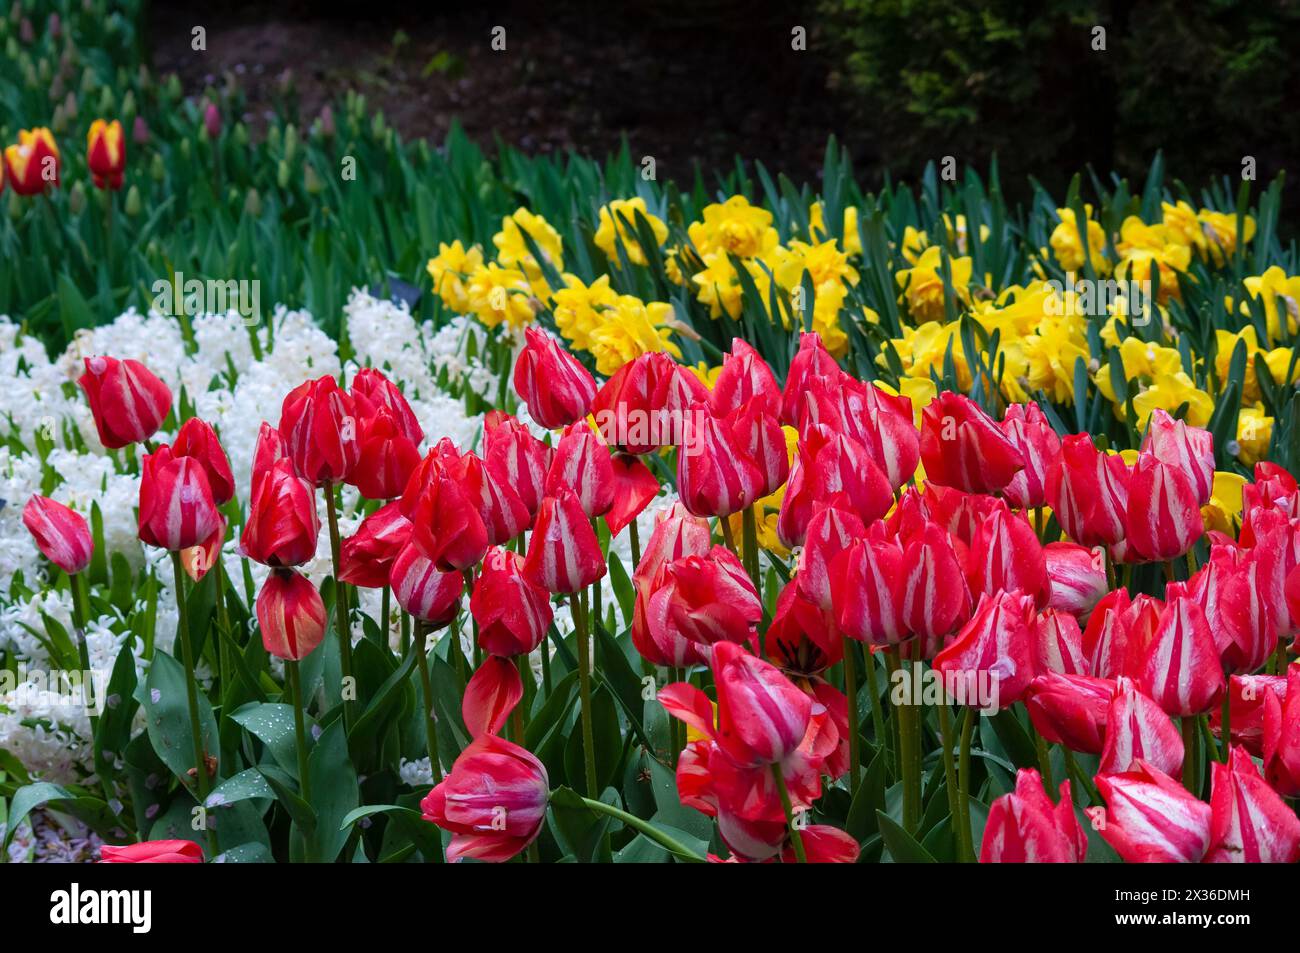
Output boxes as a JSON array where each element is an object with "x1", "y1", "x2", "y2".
[{"x1": 147, "y1": 0, "x2": 1300, "y2": 207}]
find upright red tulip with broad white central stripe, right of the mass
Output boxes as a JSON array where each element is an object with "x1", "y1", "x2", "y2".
[{"x1": 1138, "y1": 597, "x2": 1225, "y2": 715}]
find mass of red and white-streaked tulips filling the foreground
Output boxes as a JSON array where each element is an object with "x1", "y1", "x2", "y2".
[{"x1": 17, "y1": 321, "x2": 1300, "y2": 861}]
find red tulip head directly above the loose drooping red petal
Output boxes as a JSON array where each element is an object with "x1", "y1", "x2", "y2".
[{"x1": 469, "y1": 547, "x2": 553, "y2": 655}]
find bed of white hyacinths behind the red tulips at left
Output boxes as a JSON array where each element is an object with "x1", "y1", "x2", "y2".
[{"x1": 0, "y1": 290, "x2": 672, "y2": 783}]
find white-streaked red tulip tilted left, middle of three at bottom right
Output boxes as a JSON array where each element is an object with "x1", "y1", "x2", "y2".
[{"x1": 1097, "y1": 759, "x2": 1210, "y2": 863}]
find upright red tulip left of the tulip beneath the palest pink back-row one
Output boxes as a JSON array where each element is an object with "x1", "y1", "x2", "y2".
[{"x1": 1048, "y1": 433, "x2": 1128, "y2": 546}]
